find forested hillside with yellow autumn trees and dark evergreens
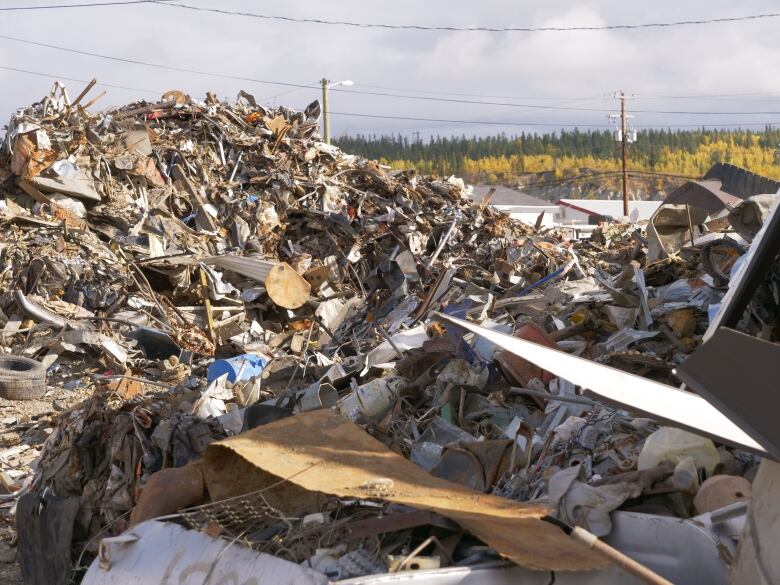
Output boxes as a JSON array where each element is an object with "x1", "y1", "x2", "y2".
[{"x1": 334, "y1": 127, "x2": 780, "y2": 185}]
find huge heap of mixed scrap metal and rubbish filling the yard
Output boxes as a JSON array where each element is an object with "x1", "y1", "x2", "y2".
[{"x1": 0, "y1": 86, "x2": 780, "y2": 579}]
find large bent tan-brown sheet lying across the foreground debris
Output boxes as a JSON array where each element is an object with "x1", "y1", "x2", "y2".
[{"x1": 204, "y1": 410, "x2": 606, "y2": 570}]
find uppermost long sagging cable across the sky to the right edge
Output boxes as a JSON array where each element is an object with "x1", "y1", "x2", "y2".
[{"x1": 148, "y1": 0, "x2": 780, "y2": 32}]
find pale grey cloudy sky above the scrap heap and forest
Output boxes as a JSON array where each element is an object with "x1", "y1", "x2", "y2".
[{"x1": 0, "y1": 0, "x2": 780, "y2": 135}]
